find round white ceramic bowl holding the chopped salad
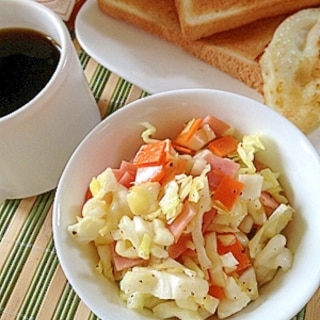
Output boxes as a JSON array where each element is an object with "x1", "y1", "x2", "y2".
[{"x1": 53, "y1": 89, "x2": 320, "y2": 320}]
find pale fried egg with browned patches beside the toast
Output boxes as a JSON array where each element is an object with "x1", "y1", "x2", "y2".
[{"x1": 260, "y1": 8, "x2": 320, "y2": 133}]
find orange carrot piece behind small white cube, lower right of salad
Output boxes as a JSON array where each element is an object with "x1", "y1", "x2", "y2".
[{"x1": 217, "y1": 237, "x2": 251, "y2": 273}]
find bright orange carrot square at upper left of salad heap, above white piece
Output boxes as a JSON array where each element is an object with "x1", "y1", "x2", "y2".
[{"x1": 132, "y1": 141, "x2": 167, "y2": 167}]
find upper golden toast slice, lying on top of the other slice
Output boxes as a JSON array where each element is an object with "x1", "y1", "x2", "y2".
[{"x1": 175, "y1": 0, "x2": 320, "y2": 40}]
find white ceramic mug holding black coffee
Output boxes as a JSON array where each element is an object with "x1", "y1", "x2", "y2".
[{"x1": 0, "y1": 0, "x2": 101, "y2": 204}]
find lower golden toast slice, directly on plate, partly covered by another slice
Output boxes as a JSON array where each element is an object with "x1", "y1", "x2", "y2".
[{"x1": 97, "y1": 0, "x2": 285, "y2": 93}]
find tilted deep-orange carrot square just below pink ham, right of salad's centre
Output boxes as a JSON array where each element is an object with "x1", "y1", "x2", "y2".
[{"x1": 213, "y1": 176, "x2": 244, "y2": 210}]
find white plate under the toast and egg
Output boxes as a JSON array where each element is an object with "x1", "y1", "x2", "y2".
[{"x1": 75, "y1": 0, "x2": 320, "y2": 152}]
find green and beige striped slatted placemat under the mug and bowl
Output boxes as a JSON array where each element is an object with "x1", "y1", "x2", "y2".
[{"x1": 0, "y1": 42, "x2": 311, "y2": 320}]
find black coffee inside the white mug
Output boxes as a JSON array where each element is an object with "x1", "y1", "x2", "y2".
[{"x1": 0, "y1": 28, "x2": 60, "y2": 117}]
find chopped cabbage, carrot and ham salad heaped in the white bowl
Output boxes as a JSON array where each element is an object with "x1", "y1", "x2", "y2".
[{"x1": 68, "y1": 115, "x2": 295, "y2": 319}]
